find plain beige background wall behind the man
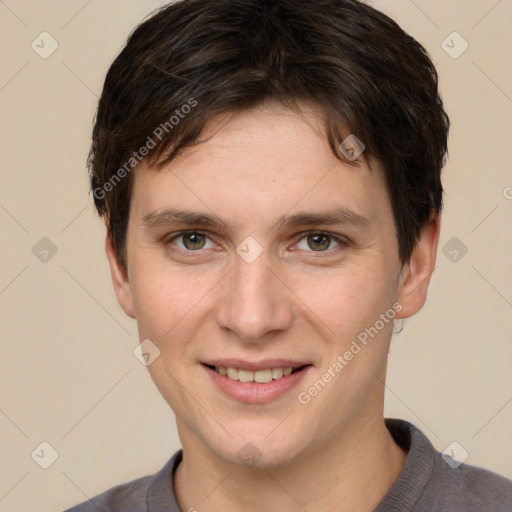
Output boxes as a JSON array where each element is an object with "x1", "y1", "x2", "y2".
[{"x1": 0, "y1": 0, "x2": 512, "y2": 512}]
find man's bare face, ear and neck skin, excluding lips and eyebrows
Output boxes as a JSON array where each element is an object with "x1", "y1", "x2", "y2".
[{"x1": 106, "y1": 104, "x2": 440, "y2": 512}]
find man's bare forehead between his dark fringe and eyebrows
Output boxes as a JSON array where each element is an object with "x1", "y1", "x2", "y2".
[{"x1": 132, "y1": 105, "x2": 391, "y2": 230}]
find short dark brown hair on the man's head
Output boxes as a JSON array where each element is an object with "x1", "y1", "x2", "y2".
[{"x1": 88, "y1": 0, "x2": 450, "y2": 266}]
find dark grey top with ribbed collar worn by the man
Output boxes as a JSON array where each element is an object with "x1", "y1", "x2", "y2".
[{"x1": 66, "y1": 419, "x2": 512, "y2": 512}]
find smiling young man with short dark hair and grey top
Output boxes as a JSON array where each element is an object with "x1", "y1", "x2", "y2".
[{"x1": 66, "y1": 0, "x2": 512, "y2": 512}]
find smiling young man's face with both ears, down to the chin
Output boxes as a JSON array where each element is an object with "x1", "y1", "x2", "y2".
[{"x1": 107, "y1": 105, "x2": 438, "y2": 466}]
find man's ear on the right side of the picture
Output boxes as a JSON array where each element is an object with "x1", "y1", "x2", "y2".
[{"x1": 396, "y1": 215, "x2": 441, "y2": 318}]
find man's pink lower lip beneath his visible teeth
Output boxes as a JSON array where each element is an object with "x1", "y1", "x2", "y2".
[{"x1": 203, "y1": 365, "x2": 311, "y2": 404}]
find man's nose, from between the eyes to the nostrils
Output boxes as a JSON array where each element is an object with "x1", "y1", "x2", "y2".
[{"x1": 216, "y1": 247, "x2": 294, "y2": 343}]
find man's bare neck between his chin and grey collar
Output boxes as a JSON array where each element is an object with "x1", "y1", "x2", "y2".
[{"x1": 174, "y1": 415, "x2": 407, "y2": 512}]
